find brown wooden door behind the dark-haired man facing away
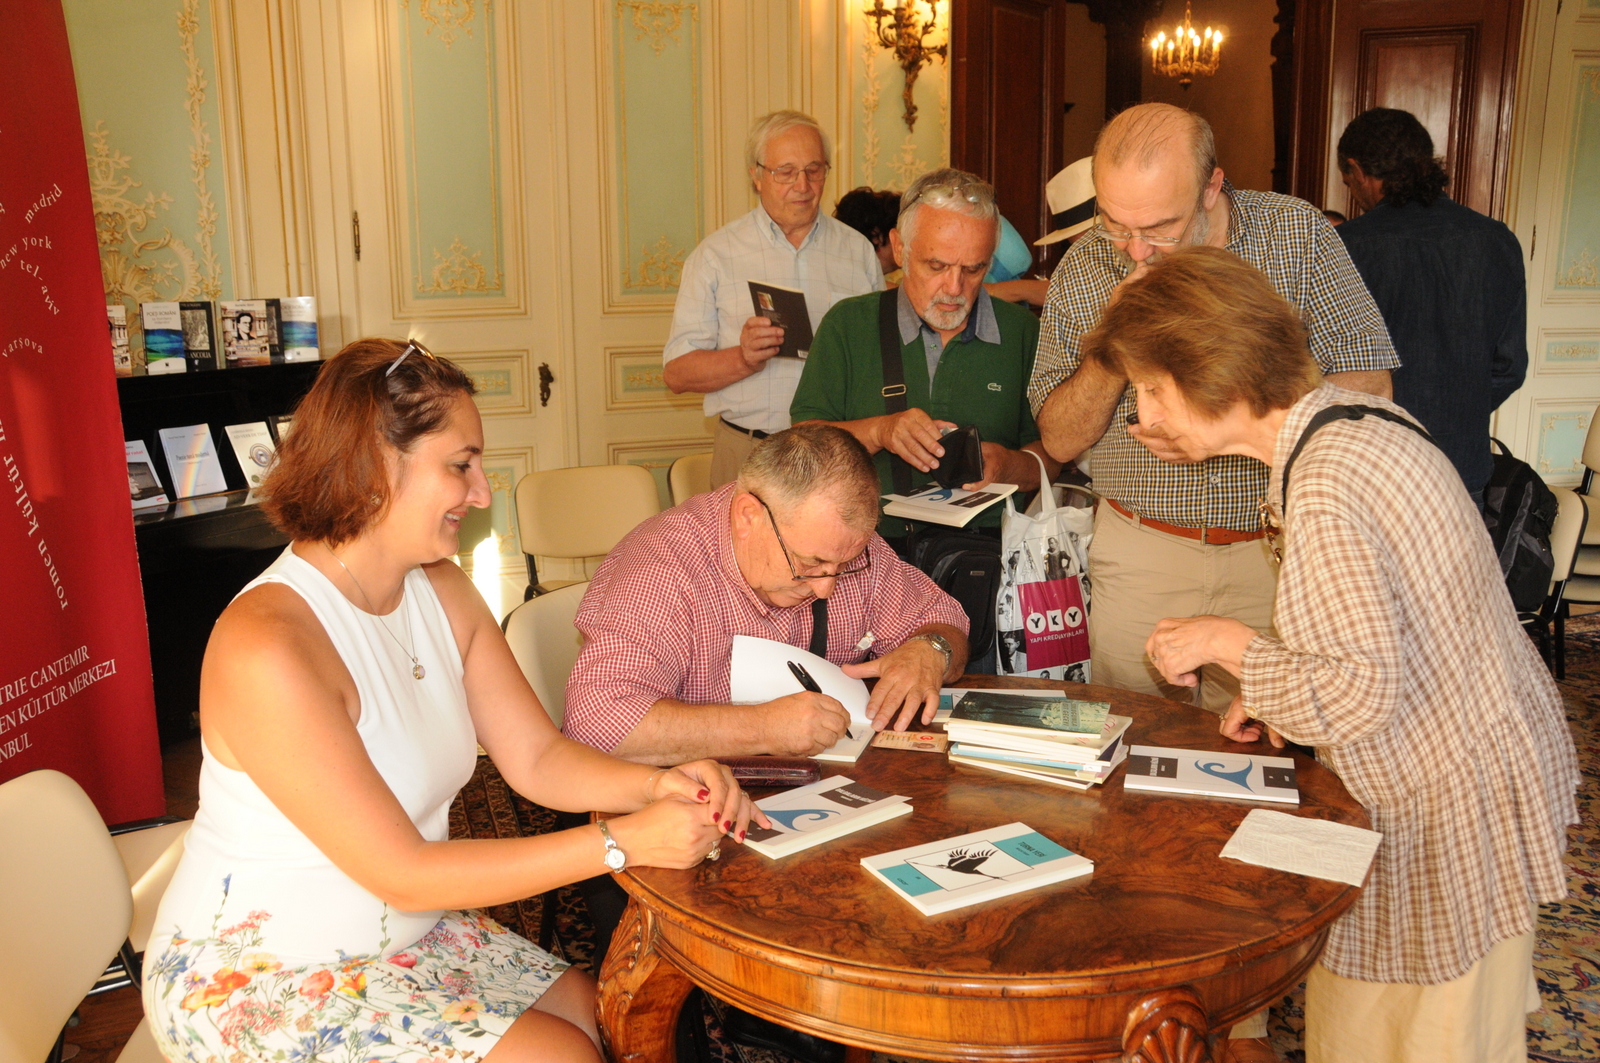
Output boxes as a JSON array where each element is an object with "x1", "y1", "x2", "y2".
[{"x1": 1291, "y1": 0, "x2": 1523, "y2": 218}]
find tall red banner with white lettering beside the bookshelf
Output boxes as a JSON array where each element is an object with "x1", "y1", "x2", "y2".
[{"x1": 0, "y1": 0, "x2": 166, "y2": 823}]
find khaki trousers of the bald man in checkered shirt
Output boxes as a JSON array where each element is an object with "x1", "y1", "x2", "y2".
[{"x1": 1090, "y1": 504, "x2": 1278, "y2": 716}]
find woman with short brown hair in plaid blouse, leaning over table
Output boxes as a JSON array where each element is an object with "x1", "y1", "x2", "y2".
[{"x1": 1085, "y1": 247, "x2": 1578, "y2": 1063}]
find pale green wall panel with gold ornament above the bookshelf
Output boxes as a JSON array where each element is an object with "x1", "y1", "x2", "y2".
[{"x1": 62, "y1": 0, "x2": 233, "y2": 312}]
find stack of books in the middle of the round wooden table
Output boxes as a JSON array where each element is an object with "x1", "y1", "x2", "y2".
[{"x1": 944, "y1": 690, "x2": 1133, "y2": 789}]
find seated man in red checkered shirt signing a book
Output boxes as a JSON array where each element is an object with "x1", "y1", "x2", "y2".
[{"x1": 565, "y1": 424, "x2": 966, "y2": 764}]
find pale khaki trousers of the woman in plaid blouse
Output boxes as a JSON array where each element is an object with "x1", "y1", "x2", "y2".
[{"x1": 1306, "y1": 933, "x2": 1539, "y2": 1063}]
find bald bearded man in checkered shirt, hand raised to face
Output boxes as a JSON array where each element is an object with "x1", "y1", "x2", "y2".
[{"x1": 1029, "y1": 104, "x2": 1400, "y2": 714}]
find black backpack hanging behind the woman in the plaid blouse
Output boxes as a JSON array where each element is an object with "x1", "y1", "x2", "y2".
[{"x1": 1483, "y1": 439, "x2": 1558, "y2": 613}]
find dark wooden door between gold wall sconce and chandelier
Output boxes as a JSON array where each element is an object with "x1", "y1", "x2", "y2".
[{"x1": 950, "y1": 0, "x2": 1066, "y2": 264}]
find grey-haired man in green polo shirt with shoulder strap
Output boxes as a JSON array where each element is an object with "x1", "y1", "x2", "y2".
[{"x1": 789, "y1": 170, "x2": 1059, "y2": 548}]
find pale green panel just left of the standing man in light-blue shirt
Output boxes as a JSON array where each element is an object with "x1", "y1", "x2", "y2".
[{"x1": 613, "y1": 0, "x2": 704, "y2": 295}]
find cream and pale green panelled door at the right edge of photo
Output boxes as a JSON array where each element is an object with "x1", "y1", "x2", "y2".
[{"x1": 1494, "y1": 0, "x2": 1600, "y2": 483}]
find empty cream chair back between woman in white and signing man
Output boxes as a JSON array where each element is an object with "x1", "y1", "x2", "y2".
[{"x1": 517, "y1": 466, "x2": 661, "y2": 597}]
